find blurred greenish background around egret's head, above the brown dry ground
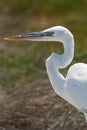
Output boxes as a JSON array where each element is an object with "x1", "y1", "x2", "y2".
[{"x1": 0, "y1": 0, "x2": 87, "y2": 86}]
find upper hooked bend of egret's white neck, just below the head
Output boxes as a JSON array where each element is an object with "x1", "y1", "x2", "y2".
[{"x1": 51, "y1": 33, "x2": 74, "y2": 68}]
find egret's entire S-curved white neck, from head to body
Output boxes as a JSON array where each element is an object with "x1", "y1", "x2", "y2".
[{"x1": 46, "y1": 31, "x2": 74, "y2": 101}]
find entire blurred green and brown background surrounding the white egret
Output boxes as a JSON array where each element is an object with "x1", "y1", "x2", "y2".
[{"x1": 0, "y1": 0, "x2": 87, "y2": 130}]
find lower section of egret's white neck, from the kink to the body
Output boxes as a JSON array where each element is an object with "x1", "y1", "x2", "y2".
[{"x1": 46, "y1": 59, "x2": 67, "y2": 100}]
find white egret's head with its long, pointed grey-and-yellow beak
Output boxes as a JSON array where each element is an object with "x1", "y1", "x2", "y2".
[{"x1": 4, "y1": 26, "x2": 72, "y2": 42}]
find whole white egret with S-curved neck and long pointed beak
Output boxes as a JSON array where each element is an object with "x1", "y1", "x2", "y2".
[{"x1": 4, "y1": 26, "x2": 87, "y2": 122}]
